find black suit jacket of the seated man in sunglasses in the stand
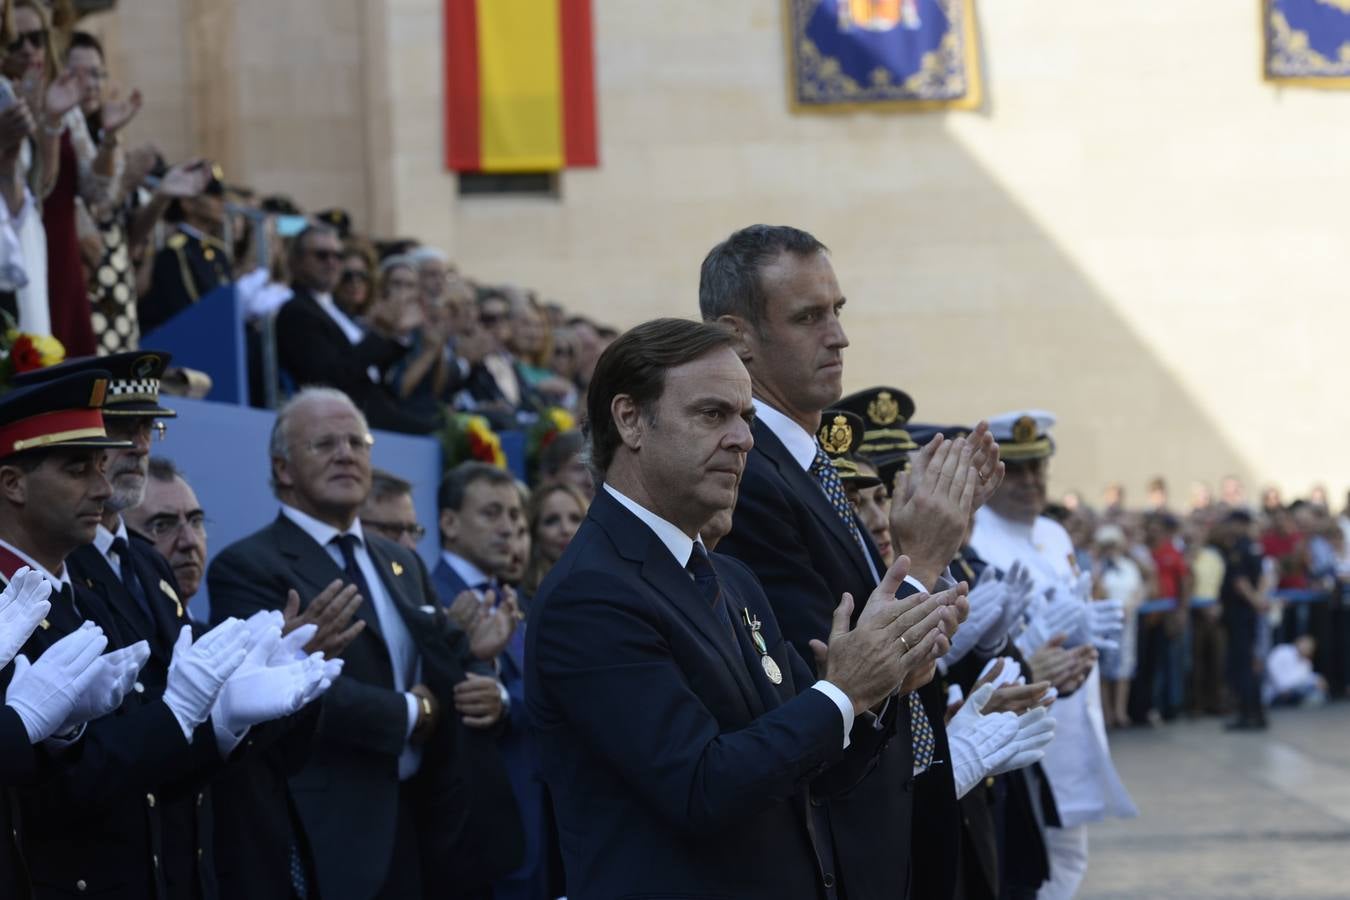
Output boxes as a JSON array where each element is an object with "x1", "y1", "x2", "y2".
[{"x1": 277, "y1": 285, "x2": 432, "y2": 434}]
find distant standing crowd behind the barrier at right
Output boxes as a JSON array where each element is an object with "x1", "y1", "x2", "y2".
[{"x1": 1049, "y1": 476, "x2": 1350, "y2": 729}]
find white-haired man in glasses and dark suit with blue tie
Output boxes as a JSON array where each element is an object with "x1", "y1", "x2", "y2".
[{"x1": 207, "y1": 389, "x2": 518, "y2": 900}]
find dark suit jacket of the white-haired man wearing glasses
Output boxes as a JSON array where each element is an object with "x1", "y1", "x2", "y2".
[{"x1": 208, "y1": 515, "x2": 518, "y2": 900}]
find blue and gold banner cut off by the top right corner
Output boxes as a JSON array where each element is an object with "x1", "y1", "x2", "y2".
[{"x1": 1262, "y1": 0, "x2": 1350, "y2": 88}]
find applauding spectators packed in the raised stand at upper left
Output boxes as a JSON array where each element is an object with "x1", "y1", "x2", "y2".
[{"x1": 0, "y1": 0, "x2": 616, "y2": 447}]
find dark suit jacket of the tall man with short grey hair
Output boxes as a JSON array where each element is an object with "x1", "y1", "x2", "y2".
[{"x1": 718, "y1": 422, "x2": 960, "y2": 900}]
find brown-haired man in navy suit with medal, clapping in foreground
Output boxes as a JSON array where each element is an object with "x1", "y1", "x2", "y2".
[{"x1": 525, "y1": 318, "x2": 954, "y2": 900}]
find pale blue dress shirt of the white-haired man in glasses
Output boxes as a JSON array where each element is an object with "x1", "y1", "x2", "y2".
[{"x1": 281, "y1": 503, "x2": 421, "y2": 781}]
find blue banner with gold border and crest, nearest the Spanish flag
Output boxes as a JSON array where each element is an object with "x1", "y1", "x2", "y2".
[{"x1": 786, "y1": 0, "x2": 980, "y2": 109}]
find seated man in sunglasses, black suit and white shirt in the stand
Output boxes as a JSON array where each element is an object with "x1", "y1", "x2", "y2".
[{"x1": 267, "y1": 225, "x2": 433, "y2": 434}]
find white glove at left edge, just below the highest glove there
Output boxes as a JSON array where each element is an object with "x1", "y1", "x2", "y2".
[{"x1": 4, "y1": 622, "x2": 108, "y2": 743}]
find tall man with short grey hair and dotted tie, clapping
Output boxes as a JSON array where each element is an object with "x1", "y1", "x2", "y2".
[{"x1": 699, "y1": 225, "x2": 1000, "y2": 900}]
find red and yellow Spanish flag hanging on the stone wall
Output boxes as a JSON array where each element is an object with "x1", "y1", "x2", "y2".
[{"x1": 444, "y1": 0, "x2": 598, "y2": 171}]
